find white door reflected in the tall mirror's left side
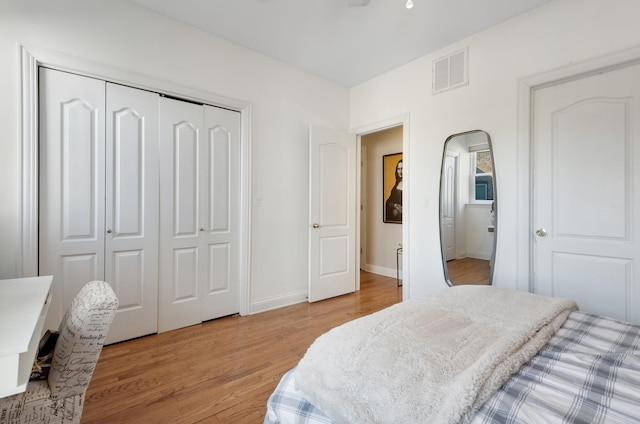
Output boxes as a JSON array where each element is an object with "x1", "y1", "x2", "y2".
[{"x1": 440, "y1": 154, "x2": 457, "y2": 261}]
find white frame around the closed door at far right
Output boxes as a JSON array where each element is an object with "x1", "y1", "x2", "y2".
[{"x1": 515, "y1": 47, "x2": 640, "y2": 292}]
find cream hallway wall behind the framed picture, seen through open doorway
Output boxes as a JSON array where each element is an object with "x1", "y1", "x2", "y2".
[{"x1": 360, "y1": 127, "x2": 402, "y2": 278}]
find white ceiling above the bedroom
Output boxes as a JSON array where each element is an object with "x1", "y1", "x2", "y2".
[{"x1": 129, "y1": 0, "x2": 551, "y2": 87}]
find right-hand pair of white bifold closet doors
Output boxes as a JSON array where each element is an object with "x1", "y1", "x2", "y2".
[{"x1": 158, "y1": 98, "x2": 240, "y2": 331}]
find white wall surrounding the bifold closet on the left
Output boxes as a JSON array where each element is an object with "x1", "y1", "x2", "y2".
[{"x1": 0, "y1": 0, "x2": 349, "y2": 310}]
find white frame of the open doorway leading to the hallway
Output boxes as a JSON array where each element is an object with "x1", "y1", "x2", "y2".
[{"x1": 351, "y1": 113, "x2": 411, "y2": 299}]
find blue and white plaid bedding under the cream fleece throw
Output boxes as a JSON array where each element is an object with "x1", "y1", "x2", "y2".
[{"x1": 264, "y1": 311, "x2": 640, "y2": 424}]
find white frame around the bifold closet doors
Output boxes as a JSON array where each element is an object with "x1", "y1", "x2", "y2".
[{"x1": 18, "y1": 46, "x2": 251, "y2": 315}]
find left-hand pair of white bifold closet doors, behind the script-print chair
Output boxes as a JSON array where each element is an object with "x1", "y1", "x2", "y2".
[{"x1": 39, "y1": 68, "x2": 158, "y2": 343}]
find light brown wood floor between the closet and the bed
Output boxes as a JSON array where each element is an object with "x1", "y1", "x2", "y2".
[{"x1": 82, "y1": 272, "x2": 402, "y2": 424}]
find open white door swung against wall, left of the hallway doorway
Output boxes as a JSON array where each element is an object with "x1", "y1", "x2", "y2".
[{"x1": 308, "y1": 127, "x2": 358, "y2": 302}]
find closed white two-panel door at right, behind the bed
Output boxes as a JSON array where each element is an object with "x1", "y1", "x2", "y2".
[{"x1": 532, "y1": 65, "x2": 640, "y2": 323}]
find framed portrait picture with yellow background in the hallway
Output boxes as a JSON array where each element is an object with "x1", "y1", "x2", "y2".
[{"x1": 382, "y1": 153, "x2": 402, "y2": 224}]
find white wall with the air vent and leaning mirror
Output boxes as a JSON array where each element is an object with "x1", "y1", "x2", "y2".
[{"x1": 351, "y1": 0, "x2": 640, "y2": 297}]
